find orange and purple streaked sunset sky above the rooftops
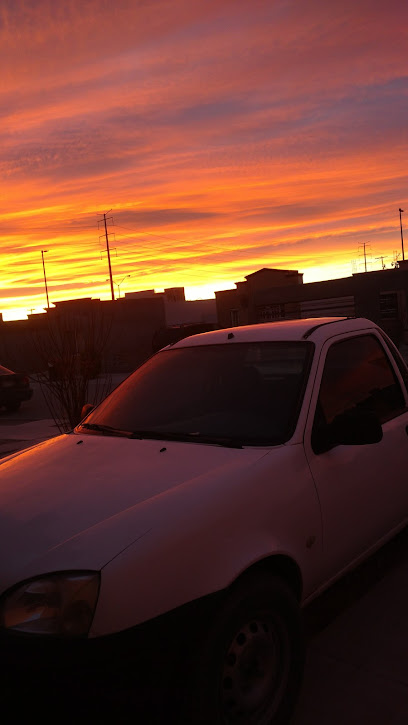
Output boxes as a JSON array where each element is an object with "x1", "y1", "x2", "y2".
[{"x1": 0, "y1": 0, "x2": 408, "y2": 319}]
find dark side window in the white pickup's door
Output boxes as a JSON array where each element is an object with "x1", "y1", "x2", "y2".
[{"x1": 312, "y1": 335, "x2": 405, "y2": 448}]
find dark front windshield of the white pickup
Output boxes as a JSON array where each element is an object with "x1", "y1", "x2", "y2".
[{"x1": 77, "y1": 342, "x2": 313, "y2": 446}]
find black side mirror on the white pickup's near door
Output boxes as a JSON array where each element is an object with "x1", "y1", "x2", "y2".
[{"x1": 313, "y1": 409, "x2": 383, "y2": 453}]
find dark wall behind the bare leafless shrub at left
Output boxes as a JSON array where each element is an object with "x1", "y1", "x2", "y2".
[{"x1": 0, "y1": 296, "x2": 165, "y2": 373}]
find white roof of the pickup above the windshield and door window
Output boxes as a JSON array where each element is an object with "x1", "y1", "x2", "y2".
[{"x1": 169, "y1": 317, "x2": 377, "y2": 348}]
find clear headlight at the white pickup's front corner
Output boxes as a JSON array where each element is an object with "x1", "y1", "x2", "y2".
[{"x1": 0, "y1": 571, "x2": 100, "y2": 637}]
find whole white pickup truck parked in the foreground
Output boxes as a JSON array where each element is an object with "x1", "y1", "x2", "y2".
[{"x1": 0, "y1": 318, "x2": 408, "y2": 725}]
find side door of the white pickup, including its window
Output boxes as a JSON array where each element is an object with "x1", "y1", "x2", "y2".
[{"x1": 305, "y1": 329, "x2": 408, "y2": 579}]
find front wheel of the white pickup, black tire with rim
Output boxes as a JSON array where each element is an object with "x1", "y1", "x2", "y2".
[{"x1": 186, "y1": 573, "x2": 304, "y2": 725}]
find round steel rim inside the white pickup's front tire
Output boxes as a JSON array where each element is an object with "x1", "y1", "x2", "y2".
[{"x1": 221, "y1": 615, "x2": 289, "y2": 725}]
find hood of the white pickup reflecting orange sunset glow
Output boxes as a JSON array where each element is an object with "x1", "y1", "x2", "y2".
[{"x1": 0, "y1": 433, "x2": 266, "y2": 592}]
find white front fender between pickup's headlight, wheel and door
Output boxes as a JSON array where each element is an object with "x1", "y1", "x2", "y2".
[{"x1": 90, "y1": 445, "x2": 322, "y2": 637}]
